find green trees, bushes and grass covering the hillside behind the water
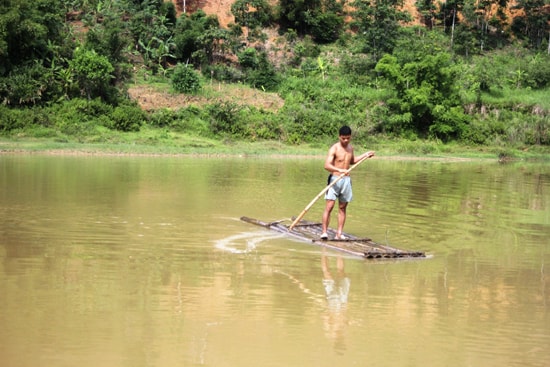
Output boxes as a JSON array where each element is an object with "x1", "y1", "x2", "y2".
[{"x1": 0, "y1": 0, "x2": 550, "y2": 160}]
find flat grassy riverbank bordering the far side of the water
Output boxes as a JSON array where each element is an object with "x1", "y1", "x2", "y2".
[{"x1": 4, "y1": 135, "x2": 550, "y2": 161}]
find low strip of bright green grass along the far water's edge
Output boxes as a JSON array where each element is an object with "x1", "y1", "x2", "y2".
[{"x1": 0, "y1": 127, "x2": 550, "y2": 161}]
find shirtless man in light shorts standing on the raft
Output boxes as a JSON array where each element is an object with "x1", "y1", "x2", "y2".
[{"x1": 321, "y1": 126, "x2": 374, "y2": 240}]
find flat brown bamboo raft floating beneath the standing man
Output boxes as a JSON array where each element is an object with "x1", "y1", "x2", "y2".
[{"x1": 241, "y1": 217, "x2": 426, "y2": 259}]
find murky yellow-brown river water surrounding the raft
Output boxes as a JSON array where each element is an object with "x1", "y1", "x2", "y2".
[{"x1": 0, "y1": 155, "x2": 550, "y2": 367}]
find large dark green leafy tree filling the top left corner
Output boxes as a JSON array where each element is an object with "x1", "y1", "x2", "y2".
[{"x1": 0, "y1": 0, "x2": 74, "y2": 106}]
